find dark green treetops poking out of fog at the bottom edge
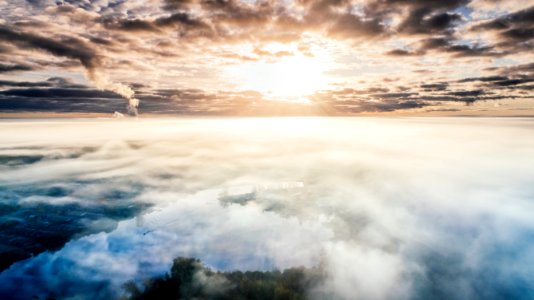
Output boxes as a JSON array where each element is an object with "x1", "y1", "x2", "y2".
[{"x1": 129, "y1": 257, "x2": 324, "y2": 300}]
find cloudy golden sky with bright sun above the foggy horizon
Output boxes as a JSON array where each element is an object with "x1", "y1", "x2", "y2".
[{"x1": 0, "y1": 0, "x2": 534, "y2": 116}]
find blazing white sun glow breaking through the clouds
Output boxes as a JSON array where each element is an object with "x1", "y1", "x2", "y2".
[{"x1": 225, "y1": 54, "x2": 328, "y2": 102}]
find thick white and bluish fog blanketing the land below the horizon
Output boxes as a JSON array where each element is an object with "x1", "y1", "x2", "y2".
[{"x1": 0, "y1": 118, "x2": 534, "y2": 299}]
